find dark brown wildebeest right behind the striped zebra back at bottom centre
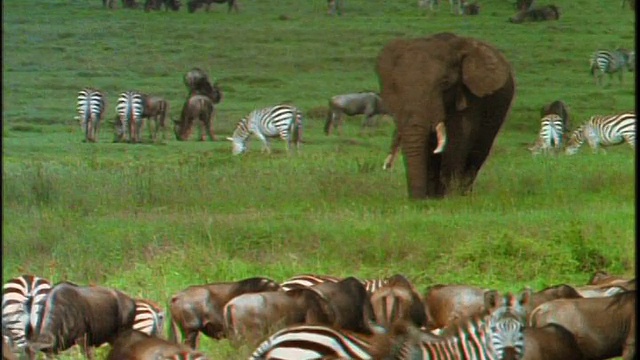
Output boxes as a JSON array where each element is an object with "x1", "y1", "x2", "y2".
[{"x1": 307, "y1": 276, "x2": 373, "y2": 334}]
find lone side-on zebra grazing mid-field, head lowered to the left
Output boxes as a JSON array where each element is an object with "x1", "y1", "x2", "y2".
[{"x1": 227, "y1": 105, "x2": 302, "y2": 155}]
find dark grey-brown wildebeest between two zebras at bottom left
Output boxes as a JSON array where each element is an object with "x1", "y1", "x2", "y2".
[{"x1": 30, "y1": 282, "x2": 136, "y2": 359}]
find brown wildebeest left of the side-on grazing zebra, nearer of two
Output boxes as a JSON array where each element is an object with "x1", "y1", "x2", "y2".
[{"x1": 173, "y1": 95, "x2": 216, "y2": 141}]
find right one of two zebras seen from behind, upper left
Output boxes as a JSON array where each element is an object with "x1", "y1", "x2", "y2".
[{"x1": 116, "y1": 91, "x2": 144, "y2": 142}]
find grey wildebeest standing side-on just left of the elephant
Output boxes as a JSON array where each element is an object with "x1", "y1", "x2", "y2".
[{"x1": 324, "y1": 91, "x2": 387, "y2": 135}]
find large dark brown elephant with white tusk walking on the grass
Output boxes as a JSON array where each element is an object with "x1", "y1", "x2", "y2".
[{"x1": 376, "y1": 33, "x2": 516, "y2": 199}]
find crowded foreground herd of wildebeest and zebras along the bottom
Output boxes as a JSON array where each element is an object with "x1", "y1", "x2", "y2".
[{"x1": 2, "y1": 272, "x2": 636, "y2": 360}]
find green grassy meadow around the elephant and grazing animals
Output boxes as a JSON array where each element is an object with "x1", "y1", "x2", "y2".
[{"x1": 2, "y1": 0, "x2": 635, "y2": 359}]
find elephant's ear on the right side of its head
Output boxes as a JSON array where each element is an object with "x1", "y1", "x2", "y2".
[{"x1": 462, "y1": 40, "x2": 510, "y2": 97}]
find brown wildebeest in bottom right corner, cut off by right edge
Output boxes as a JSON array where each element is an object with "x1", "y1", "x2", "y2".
[{"x1": 531, "y1": 291, "x2": 636, "y2": 360}]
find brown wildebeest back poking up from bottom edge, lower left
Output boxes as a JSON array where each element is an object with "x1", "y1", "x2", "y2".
[{"x1": 107, "y1": 330, "x2": 206, "y2": 360}]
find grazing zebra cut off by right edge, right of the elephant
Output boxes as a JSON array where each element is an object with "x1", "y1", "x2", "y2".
[{"x1": 566, "y1": 112, "x2": 636, "y2": 155}]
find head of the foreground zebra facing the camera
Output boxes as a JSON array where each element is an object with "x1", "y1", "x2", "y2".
[{"x1": 484, "y1": 289, "x2": 532, "y2": 360}]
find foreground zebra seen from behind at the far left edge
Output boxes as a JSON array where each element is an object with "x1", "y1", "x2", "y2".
[{"x1": 2, "y1": 275, "x2": 51, "y2": 358}]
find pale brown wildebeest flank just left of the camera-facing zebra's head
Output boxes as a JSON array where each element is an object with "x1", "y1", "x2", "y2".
[{"x1": 423, "y1": 284, "x2": 487, "y2": 330}]
